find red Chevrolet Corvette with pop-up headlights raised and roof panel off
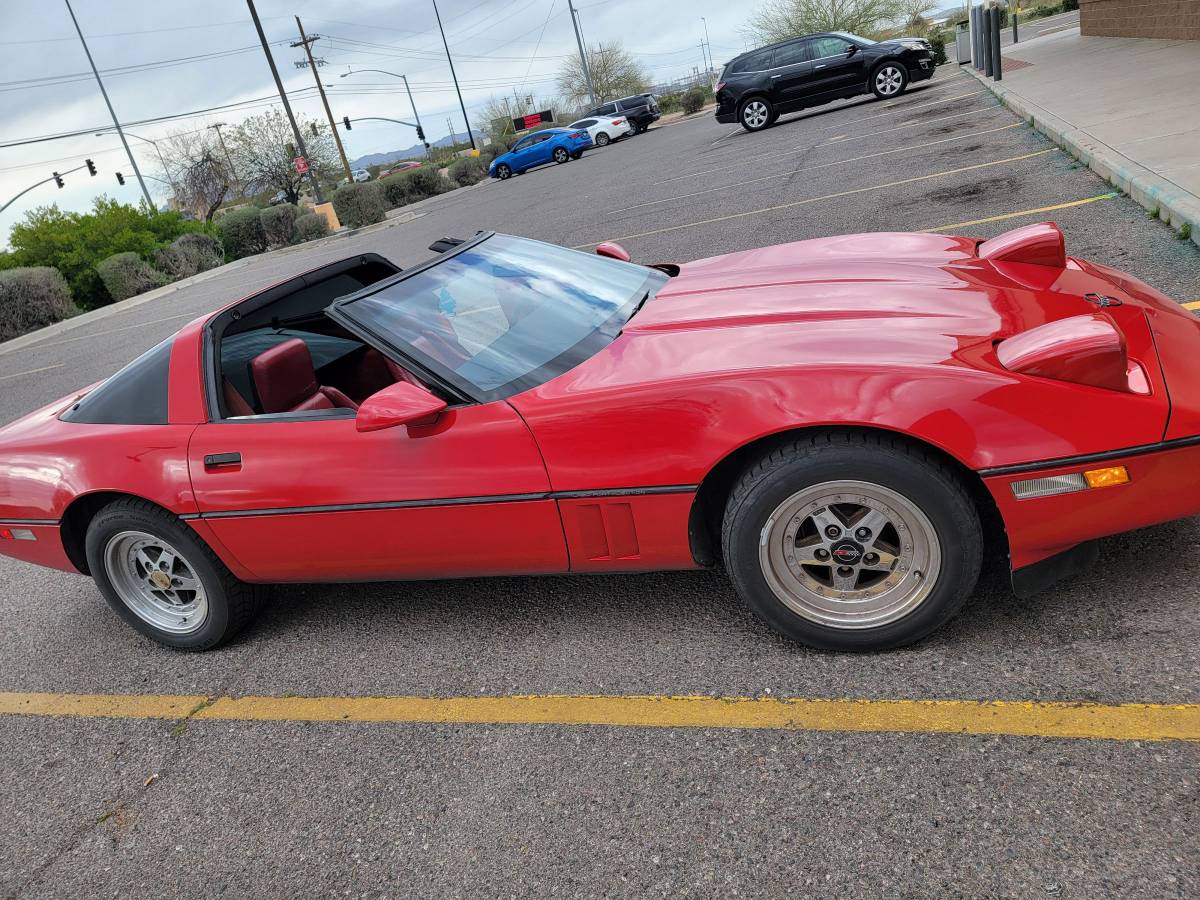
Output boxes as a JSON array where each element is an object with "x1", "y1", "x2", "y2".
[{"x1": 0, "y1": 224, "x2": 1200, "y2": 649}]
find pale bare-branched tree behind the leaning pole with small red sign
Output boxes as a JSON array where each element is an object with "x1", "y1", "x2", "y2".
[{"x1": 226, "y1": 107, "x2": 341, "y2": 203}]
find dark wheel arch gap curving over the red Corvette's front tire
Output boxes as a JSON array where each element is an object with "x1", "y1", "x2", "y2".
[{"x1": 688, "y1": 425, "x2": 1008, "y2": 565}]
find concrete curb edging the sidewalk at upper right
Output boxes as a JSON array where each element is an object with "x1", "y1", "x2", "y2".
[{"x1": 960, "y1": 65, "x2": 1200, "y2": 245}]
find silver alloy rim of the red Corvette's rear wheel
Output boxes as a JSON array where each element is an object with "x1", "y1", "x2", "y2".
[{"x1": 104, "y1": 532, "x2": 209, "y2": 635}]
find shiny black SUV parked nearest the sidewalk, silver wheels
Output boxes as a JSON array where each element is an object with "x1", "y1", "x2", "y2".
[{"x1": 716, "y1": 31, "x2": 934, "y2": 131}]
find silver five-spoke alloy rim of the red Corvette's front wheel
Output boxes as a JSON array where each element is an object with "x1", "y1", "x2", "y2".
[{"x1": 758, "y1": 481, "x2": 942, "y2": 629}]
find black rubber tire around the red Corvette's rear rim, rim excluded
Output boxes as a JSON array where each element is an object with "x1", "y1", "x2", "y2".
[{"x1": 85, "y1": 498, "x2": 265, "y2": 650}]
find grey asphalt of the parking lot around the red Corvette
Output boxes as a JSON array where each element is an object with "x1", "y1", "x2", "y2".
[{"x1": 0, "y1": 66, "x2": 1200, "y2": 898}]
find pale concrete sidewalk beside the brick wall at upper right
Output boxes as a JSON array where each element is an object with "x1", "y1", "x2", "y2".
[{"x1": 964, "y1": 28, "x2": 1200, "y2": 244}]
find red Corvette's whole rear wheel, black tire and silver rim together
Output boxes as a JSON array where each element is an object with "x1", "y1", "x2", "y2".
[{"x1": 85, "y1": 498, "x2": 264, "y2": 650}]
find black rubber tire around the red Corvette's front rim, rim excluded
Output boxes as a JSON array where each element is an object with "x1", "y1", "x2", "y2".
[{"x1": 721, "y1": 432, "x2": 983, "y2": 650}]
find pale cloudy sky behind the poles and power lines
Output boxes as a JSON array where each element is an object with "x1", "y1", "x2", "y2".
[{"x1": 0, "y1": 0, "x2": 750, "y2": 246}]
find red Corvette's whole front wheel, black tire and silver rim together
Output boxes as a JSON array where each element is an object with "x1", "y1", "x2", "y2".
[{"x1": 721, "y1": 433, "x2": 983, "y2": 650}]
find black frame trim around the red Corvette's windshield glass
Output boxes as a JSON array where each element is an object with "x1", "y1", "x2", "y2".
[{"x1": 325, "y1": 232, "x2": 667, "y2": 403}]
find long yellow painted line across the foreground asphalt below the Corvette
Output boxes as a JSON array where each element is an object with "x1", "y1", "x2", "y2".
[{"x1": 0, "y1": 694, "x2": 1200, "y2": 740}]
